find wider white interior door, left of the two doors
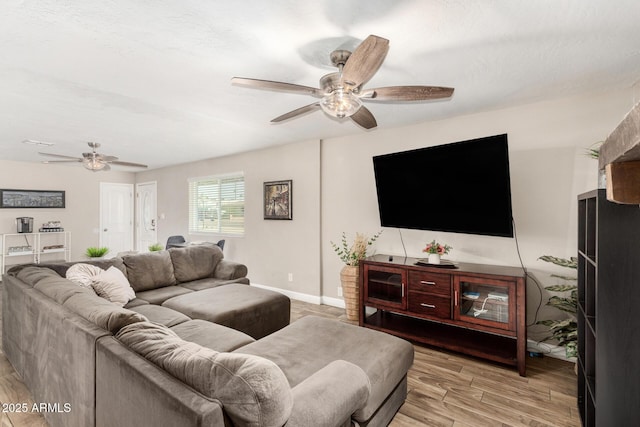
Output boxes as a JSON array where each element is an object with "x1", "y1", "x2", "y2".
[{"x1": 100, "y1": 182, "x2": 133, "y2": 257}]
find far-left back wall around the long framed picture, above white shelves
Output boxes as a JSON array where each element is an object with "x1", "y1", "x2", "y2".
[{"x1": 0, "y1": 160, "x2": 135, "y2": 260}]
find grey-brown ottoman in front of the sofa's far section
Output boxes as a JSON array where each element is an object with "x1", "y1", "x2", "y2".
[{"x1": 162, "y1": 284, "x2": 291, "y2": 339}]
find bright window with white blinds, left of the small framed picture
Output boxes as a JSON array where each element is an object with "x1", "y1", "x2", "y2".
[{"x1": 189, "y1": 173, "x2": 244, "y2": 235}]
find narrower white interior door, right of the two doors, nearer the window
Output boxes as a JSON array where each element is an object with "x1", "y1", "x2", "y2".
[{"x1": 136, "y1": 182, "x2": 158, "y2": 252}]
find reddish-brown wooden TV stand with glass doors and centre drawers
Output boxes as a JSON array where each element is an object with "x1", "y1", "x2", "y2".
[{"x1": 359, "y1": 255, "x2": 527, "y2": 376}]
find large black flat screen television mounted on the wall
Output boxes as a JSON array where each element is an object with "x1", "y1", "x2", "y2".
[{"x1": 373, "y1": 134, "x2": 513, "y2": 237}]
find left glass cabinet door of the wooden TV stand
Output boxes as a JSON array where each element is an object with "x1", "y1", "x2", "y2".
[{"x1": 364, "y1": 266, "x2": 407, "y2": 309}]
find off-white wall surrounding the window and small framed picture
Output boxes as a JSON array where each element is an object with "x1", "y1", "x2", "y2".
[{"x1": 137, "y1": 141, "x2": 321, "y2": 301}]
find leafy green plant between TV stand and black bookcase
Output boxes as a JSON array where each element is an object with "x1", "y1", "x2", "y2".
[{"x1": 536, "y1": 255, "x2": 578, "y2": 357}]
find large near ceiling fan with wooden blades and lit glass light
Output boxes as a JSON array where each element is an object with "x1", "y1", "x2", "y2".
[{"x1": 231, "y1": 35, "x2": 454, "y2": 129}]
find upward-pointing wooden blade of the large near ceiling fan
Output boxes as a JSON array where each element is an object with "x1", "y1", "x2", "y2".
[{"x1": 341, "y1": 35, "x2": 389, "y2": 88}]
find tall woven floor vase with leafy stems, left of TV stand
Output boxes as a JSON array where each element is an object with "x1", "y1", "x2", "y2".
[{"x1": 331, "y1": 231, "x2": 382, "y2": 320}]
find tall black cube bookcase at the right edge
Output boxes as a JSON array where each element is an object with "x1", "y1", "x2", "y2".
[{"x1": 577, "y1": 190, "x2": 640, "y2": 427}]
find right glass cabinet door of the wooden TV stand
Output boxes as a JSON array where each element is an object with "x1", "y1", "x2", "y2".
[{"x1": 455, "y1": 276, "x2": 516, "y2": 331}]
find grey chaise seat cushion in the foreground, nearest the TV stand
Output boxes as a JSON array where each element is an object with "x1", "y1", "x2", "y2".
[{"x1": 235, "y1": 316, "x2": 413, "y2": 422}]
